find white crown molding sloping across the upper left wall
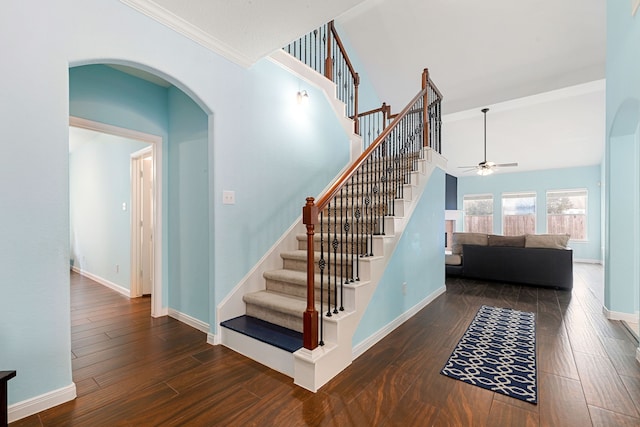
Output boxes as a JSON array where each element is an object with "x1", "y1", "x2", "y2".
[{"x1": 120, "y1": 0, "x2": 253, "y2": 68}]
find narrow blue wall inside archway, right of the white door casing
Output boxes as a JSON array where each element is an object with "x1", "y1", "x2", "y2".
[{"x1": 167, "y1": 87, "x2": 209, "y2": 323}]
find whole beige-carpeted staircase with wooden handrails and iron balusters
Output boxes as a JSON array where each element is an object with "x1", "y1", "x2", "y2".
[{"x1": 217, "y1": 22, "x2": 446, "y2": 391}]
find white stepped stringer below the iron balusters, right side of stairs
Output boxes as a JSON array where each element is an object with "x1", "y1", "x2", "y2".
[{"x1": 294, "y1": 148, "x2": 447, "y2": 392}]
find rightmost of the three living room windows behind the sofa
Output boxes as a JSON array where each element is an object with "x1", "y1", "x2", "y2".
[{"x1": 547, "y1": 189, "x2": 587, "y2": 240}]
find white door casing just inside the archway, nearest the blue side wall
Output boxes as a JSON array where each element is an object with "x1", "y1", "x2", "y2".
[{"x1": 69, "y1": 116, "x2": 168, "y2": 317}]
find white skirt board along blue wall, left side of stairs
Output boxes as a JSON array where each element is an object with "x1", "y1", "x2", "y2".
[{"x1": 218, "y1": 49, "x2": 362, "y2": 344}]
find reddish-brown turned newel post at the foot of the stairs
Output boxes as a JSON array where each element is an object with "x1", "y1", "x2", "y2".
[{"x1": 302, "y1": 197, "x2": 318, "y2": 350}]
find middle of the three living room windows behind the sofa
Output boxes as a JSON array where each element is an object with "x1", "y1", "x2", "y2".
[{"x1": 502, "y1": 192, "x2": 536, "y2": 236}]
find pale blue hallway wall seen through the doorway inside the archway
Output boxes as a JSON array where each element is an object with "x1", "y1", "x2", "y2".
[{"x1": 69, "y1": 131, "x2": 149, "y2": 290}]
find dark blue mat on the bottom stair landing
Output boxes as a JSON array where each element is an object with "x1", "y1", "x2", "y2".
[{"x1": 220, "y1": 316, "x2": 302, "y2": 353}]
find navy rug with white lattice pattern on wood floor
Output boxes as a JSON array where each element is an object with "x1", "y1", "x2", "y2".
[{"x1": 441, "y1": 305, "x2": 538, "y2": 404}]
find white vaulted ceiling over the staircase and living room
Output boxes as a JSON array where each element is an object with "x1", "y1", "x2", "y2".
[{"x1": 121, "y1": 0, "x2": 606, "y2": 175}]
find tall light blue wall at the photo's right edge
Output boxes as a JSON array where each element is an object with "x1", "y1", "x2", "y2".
[{"x1": 604, "y1": 0, "x2": 640, "y2": 316}]
